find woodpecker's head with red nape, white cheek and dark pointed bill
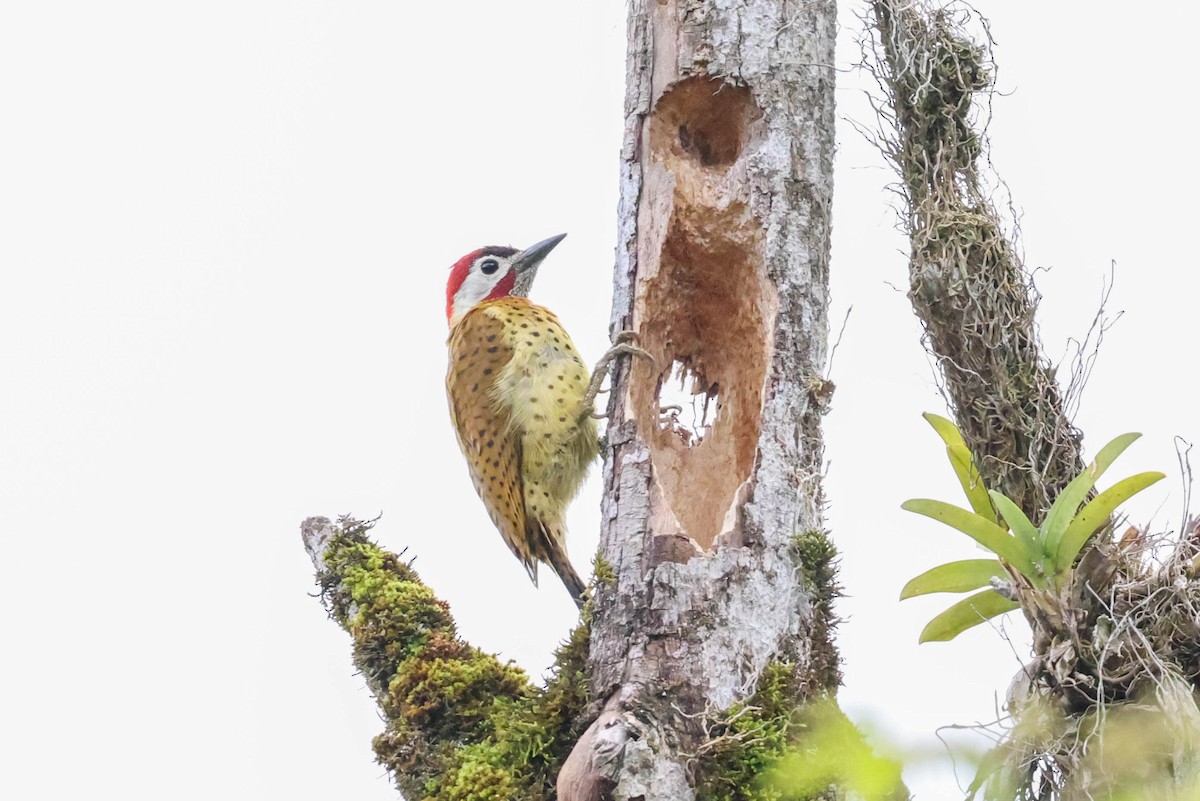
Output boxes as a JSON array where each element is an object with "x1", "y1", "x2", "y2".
[{"x1": 446, "y1": 234, "x2": 566, "y2": 325}]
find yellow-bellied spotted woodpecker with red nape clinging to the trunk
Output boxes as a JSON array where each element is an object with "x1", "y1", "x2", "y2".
[{"x1": 446, "y1": 234, "x2": 600, "y2": 607}]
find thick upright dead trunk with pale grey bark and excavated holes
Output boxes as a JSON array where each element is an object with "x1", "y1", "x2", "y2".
[{"x1": 558, "y1": 0, "x2": 836, "y2": 801}]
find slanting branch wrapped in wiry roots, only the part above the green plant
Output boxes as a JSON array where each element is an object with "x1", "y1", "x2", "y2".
[{"x1": 868, "y1": 0, "x2": 1084, "y2": 519}]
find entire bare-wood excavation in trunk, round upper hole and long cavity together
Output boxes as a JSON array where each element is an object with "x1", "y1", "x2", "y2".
[{"x1": 629, "y1": 76, "x2": 775, "y2": 551}]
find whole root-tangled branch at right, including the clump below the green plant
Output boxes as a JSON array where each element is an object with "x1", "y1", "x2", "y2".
[{"x1": 868, "y1": 0, "x2": 1200, "y2": 801}]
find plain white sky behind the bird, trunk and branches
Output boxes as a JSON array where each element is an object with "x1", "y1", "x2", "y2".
[{"x1": 0, "y1": 0, "x2": 1200, "y2": 801}]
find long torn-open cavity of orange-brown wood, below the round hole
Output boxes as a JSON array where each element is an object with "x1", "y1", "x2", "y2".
[{"x1": 630, "y1": 204, "x2": 769, "y2": 550}]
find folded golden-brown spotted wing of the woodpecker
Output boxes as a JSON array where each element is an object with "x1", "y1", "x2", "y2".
[{"x1": 446, "y1": 311, "x2": 538, "y2": 584}]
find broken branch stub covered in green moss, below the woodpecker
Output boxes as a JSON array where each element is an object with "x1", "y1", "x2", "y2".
[{"x1": 301, "y1": 517, "x2": 588, "y2": 801}]
